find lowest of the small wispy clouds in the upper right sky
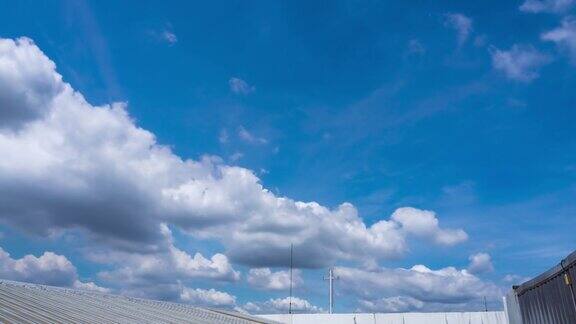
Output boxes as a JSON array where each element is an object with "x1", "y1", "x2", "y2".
[{"x1": 491, "y1": 44, "x2": 550, "y2": 82}]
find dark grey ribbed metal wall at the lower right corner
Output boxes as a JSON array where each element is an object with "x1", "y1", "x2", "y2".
[{"x1": 514, "y1": 252, "x2": 576, "y2": 324}]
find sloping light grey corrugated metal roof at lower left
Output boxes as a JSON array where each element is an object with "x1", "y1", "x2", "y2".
[{"x1": 0, "y1": 280, "x2": 275, "y2": 324}]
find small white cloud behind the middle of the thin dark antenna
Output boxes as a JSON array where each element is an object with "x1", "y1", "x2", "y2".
[{"x1": 247, "y1": 268, "x2": 303, "y2": 290}]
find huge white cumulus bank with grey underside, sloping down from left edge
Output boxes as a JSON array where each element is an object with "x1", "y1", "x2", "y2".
[{"x1": 0, "y1": 39, "x2": 466, "y2": 278}]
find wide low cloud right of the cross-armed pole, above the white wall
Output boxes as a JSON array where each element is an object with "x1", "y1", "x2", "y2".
[{"x1": 335, "y1": 265, "x2": 502, "y2": 312}]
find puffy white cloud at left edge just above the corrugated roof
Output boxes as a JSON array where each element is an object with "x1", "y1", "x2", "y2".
[{"x1": 0, "y1": 247, "x2": 108, "y2": 292}]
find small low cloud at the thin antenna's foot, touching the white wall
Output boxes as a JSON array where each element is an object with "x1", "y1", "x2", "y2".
[{"x1": 243, "y1": 297, "x2": 324, "y2": 314}]
